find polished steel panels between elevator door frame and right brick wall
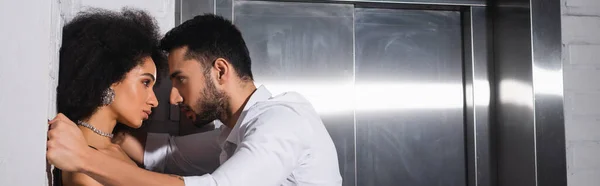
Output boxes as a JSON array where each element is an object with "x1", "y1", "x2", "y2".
[{"x1": 493, "y1": 0, "x2": 567, "y2": 186}]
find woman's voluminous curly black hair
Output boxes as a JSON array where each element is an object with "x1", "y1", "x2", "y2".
[{"x1": 57, "y1": 8, "x2": 167, "y2": 121}]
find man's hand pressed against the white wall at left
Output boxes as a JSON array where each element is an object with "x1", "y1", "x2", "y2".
[{"x1": 46, "y1": 113, "x2": 93, "y2": 172}]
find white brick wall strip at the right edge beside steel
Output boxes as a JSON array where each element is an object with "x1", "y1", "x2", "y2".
[{"x1": 562, "y1": 0, "x2": 600, "y2": 186}]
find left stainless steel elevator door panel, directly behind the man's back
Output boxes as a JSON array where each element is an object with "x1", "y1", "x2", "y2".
[{"x1": 234, "y1": 1, "x2": 355, "y2": 186}]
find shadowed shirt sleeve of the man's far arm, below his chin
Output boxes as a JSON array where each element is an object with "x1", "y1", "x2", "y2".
[{"x1": 144, "y1": 130, "x2": 221, "y2": 176}]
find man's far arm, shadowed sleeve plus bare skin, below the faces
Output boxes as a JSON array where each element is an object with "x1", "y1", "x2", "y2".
[{"x1": 113, "y1": 121, "x2": 221, "y2": 175}]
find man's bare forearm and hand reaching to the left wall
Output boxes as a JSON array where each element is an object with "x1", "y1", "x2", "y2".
[{"x1": 46, "y1": 114, "x2": 184, "y2": 186}]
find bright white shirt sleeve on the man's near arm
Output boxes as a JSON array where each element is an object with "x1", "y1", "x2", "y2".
[{"x1": 185, "y1": 108, "x2": 311, "y2": 186}]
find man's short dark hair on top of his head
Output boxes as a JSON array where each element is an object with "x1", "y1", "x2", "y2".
[{"x1": 160, "y1": 14, "x2": 254, "y2": 80}]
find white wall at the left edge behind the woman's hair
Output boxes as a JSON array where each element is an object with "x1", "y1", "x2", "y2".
[{"x1": 0, "y1": 0, "x2": 58, "y2": 185}]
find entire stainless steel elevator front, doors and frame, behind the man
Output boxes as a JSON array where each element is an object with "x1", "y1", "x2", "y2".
[{"x1": 177, "y1": 0, "x2": 566, "y2": 186}]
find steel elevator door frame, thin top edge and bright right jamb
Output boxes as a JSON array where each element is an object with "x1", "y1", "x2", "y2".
[{"x1": 176, "y1": 0, "x2": 495, "y2": 186}]
